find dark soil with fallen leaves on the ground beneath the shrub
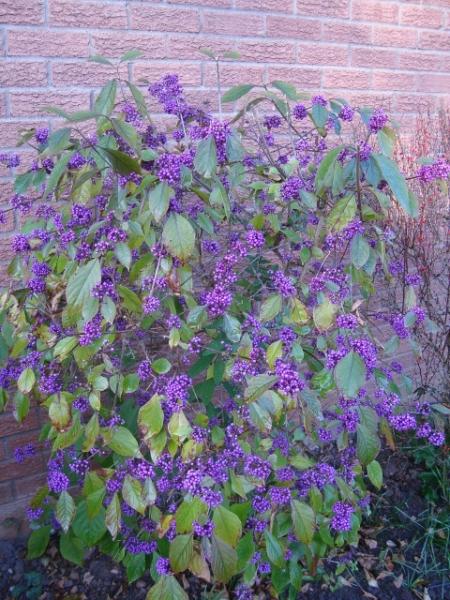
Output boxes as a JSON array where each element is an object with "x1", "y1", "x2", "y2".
[{"x1": 0, "y1": 454, "x2": 450, "y2": 600}]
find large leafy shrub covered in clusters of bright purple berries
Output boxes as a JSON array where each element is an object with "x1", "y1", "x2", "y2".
[{"x1": 0, "y1": 54, "x2": 443, "y2": 600}]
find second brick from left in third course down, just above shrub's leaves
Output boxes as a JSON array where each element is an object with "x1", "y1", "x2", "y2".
[{"x1": 51, "y1": 61, "x2": 127, "y2": 88}]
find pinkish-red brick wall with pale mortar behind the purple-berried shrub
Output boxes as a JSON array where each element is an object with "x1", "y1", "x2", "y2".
[{"x1": 0, "y1": 0, "x2": 450, "y2": 528}]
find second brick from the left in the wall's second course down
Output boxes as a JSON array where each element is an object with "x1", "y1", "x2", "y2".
[{"x1": 92, "y1": 31, "x2": 166, "y2": 59}]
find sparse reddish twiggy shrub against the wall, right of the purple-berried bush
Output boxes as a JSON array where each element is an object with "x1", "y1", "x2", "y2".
[{"x1": 386, "y1": 109, "x2": 450, "y2": 401}]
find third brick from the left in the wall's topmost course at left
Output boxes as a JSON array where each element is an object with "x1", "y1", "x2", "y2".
[{"x1": 129, "y1": 3, "x2": 200, "y2": 33}]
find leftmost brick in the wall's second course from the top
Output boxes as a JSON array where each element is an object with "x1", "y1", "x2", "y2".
[{"x1": 8, "y1": 29, "x2": 89, "y2": 58}]
